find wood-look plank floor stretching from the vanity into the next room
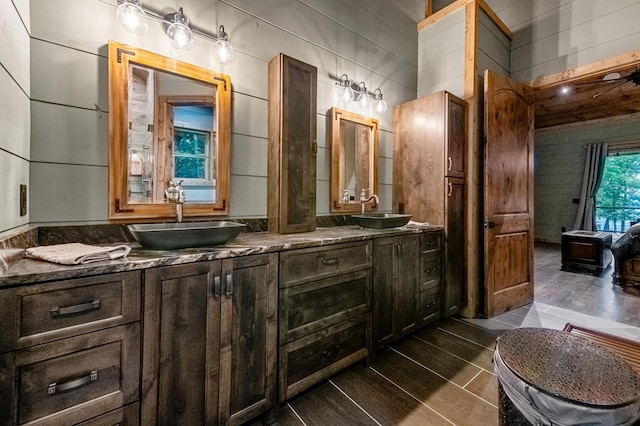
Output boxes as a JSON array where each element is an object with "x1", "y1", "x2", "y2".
[{"x1": 262, "y1": 244, "x2": 640, "y2": 426}]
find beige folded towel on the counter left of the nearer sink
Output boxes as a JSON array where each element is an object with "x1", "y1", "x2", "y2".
[{"x1": 25, "y1": 243, "x2": 131, "y2": 265}]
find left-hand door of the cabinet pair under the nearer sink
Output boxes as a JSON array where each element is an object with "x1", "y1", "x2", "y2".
[{"x1": 141, "y1": 261, "x2": 221, "y2": 425}]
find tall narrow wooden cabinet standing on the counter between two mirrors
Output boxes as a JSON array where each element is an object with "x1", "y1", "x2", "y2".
[{"x1": 267, "y1": 54, "x2": 318, "y2": 234}]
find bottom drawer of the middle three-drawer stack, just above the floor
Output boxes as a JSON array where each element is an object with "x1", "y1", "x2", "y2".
[{"x1": 280, "y1": 315, "x2": 370, "y2": 401}]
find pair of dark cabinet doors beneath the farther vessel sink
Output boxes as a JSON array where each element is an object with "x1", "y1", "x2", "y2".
[{"x1": 373, "y1": 234, "x2": 420, "y2": 349}]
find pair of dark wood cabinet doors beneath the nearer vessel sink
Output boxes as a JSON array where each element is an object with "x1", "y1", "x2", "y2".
[{"x1": 141, "y1": 254, "x2": 278, "y2": 425}]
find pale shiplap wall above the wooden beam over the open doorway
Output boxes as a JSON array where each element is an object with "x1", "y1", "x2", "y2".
[{"x1": 486, "y1": 0, "x2": 640, "y2": 82}]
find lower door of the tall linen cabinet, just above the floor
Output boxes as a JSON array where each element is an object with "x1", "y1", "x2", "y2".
[{"x1": 443, "y1": 178, "x2": 467, "y2": 316}]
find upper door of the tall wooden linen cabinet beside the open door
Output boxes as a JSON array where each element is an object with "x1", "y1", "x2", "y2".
[{"x1": 443, "y1": 92, "x2": 466, "y2": 177}]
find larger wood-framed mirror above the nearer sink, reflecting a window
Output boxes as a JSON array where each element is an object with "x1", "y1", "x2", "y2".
[{"x1": 109, "y1": 41, "x2": 231, "y2": 219}]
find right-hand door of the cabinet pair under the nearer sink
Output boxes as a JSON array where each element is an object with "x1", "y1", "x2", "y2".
[{"x1": 220, "y1": 253, "x2": 278, "y2": 424}]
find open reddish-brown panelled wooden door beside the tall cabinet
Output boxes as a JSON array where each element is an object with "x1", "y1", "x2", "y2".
[{"x1": 484, "y1": 71, "x2": 534, "y2": 317}]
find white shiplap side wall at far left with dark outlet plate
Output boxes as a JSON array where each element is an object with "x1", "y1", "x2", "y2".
[{"x1": 0, "y1": 0, "x2": 31, "y2": 232}]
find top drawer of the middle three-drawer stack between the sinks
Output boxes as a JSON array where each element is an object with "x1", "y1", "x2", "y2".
[{"x1": 280, "y1": 241, "x2": 371, "y2": 287}]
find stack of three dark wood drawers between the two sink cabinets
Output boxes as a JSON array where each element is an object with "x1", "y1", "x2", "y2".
[{"x1": 279, "y1": 241, "x2": 372, "y2": 401}]
